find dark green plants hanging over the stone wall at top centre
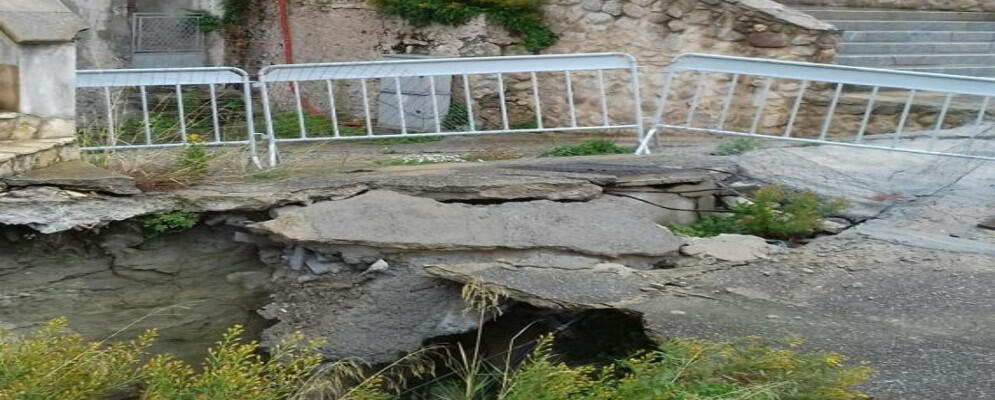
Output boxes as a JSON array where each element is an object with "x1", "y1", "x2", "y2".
[{"x1": 374, "y1": 0, "x2": 556, "y2": 51}]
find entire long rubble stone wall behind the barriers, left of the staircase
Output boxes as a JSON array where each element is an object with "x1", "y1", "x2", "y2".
[{"x1": 241, "y1": 0, "x2": 839, "y2": 134}]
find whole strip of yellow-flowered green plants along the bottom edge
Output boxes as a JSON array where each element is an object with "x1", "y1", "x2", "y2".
[{"x1": 0, "y1": 282, "x2": 871, "y2": 400}]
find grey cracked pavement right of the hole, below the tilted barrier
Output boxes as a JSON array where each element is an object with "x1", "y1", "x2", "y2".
[{"x1": 637, "y1": 130, "x2": 995, "y2": 400}]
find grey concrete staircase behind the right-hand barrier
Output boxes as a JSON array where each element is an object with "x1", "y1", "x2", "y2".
[{"x1": 785, "y1": 1, "x2": 995, "y2": 77}]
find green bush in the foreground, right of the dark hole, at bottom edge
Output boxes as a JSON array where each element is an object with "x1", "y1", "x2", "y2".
[{"x1": 588, "y1": 339, "x2": 871, "y2": 400}]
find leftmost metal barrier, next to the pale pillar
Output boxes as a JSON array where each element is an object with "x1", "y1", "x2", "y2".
[{"x1": 76, "y1": 67, "x2": 261, "y2": 166}]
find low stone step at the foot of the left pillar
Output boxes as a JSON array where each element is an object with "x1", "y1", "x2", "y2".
[{"x1": 0, "y1": 137, "x2": 79, "y2": 177}]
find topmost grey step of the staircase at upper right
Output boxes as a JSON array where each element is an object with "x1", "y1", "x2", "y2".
[{"x1": 796, "y1": 7, "x2": 995, "y2": 22}]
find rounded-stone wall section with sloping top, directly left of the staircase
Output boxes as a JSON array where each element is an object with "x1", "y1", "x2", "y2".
[{"x1": 532, "y1": 0, "x2": 840, "y2": 133}]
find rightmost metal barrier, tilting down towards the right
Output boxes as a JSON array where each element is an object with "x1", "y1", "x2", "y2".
[{"x1": 637, "y1": 54, "x2": 995, "y2": 160}]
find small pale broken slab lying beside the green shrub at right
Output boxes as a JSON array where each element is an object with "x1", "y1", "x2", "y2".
[{"x1": 681, "y1": 234, "x2": 784, "y2": 262}]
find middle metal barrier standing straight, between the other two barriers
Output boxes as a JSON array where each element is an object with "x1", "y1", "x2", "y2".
[{"x1": 259, "y1": 53, "x2": 643, "y2": 163}]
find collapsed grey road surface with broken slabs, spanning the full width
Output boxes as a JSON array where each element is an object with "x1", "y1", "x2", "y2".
[{"x1": 0, "y1": 131, "x2": 995, "y2": 399}]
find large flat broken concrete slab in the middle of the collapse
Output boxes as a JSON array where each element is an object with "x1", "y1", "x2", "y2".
[{"x1": 249, "y1": 190, "x2": 684, "y2": 257}]
